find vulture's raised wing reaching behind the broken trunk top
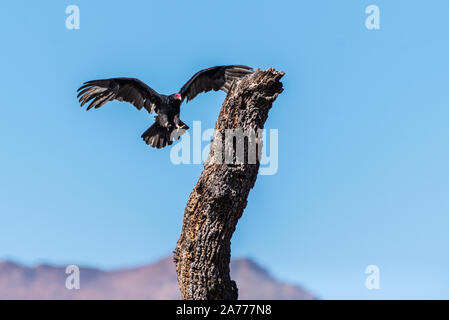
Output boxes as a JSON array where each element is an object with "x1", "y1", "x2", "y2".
[{"x1": 179, "y1": 65, "x2": 254, "y2": 102}]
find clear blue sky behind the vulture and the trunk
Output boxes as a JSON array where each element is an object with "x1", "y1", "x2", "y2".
[{"x1": 0, "y1": 0, "x2": 449, "y2": 299}]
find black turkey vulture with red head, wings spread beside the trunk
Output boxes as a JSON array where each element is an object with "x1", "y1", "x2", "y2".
[{"x1": 78, "y1": 65, "x2": 254, "y2": 149}]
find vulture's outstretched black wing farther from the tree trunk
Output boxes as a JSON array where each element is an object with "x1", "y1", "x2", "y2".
[{"x1": 78, "y1": 78, "x2": 161, "y2": 113}]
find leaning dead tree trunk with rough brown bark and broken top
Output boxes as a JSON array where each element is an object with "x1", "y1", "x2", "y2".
[{"x1": 174, "y1": 68, "x2": 284, "y2": 300}]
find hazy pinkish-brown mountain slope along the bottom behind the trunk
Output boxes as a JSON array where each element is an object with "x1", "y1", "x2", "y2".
[{"x1": 0, "y1": 258, "x2": 313, "y2": 300}]
